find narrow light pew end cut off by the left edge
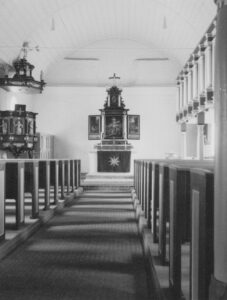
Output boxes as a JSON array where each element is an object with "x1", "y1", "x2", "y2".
[{"x1": 0, "y1": 161, "x2": 5, "y2": 241}]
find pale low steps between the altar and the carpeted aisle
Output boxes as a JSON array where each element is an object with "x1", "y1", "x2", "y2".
[{"x1": 81, "y1": 173, "x2": 133, "y2": 191}]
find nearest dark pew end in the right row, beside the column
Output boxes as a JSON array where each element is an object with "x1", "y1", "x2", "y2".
[{"x1": 190, "y1": 169, "x2": 214, "y2": 300}]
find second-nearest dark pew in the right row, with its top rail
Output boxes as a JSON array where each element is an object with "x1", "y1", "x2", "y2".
[{"x1": 169, "y1": 162, "x2": 213, "y2": 299}]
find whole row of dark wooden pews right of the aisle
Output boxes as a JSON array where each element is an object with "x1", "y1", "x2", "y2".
[{"x1": 134, "y1": 160, "x2": 214, "y2": 300}]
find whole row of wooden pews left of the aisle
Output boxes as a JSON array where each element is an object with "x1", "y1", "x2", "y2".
[{"x1": 0, "y1": 159, "x2": 80, "y2": 239}]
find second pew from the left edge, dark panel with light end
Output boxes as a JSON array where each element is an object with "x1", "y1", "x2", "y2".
[{"x1": 5, "y1": 160, "x2": 25, "y2": 228}]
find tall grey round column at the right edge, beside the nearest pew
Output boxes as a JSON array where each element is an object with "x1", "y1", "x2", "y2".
[{"x1": 209, "y1": 0, "x2": 227, "y2": 300}]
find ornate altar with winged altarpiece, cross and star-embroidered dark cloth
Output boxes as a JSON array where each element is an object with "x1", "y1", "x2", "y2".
[{"x1": 88, "y1": 74, "x2": 140, "y2": 173}]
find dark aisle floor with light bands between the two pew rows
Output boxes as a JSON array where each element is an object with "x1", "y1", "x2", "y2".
[{"x1": 0, "y1": 191, "x2": 156, "y2": 300}]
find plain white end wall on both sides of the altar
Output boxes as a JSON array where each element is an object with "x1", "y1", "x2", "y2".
[{"x1": 30, "y1": 87, "x2": 179, "y2": 172}]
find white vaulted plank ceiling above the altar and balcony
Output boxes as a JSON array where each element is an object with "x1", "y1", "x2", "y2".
[{"x1": 0, "y1": 0, "x2": 216, "y2": 86}]
